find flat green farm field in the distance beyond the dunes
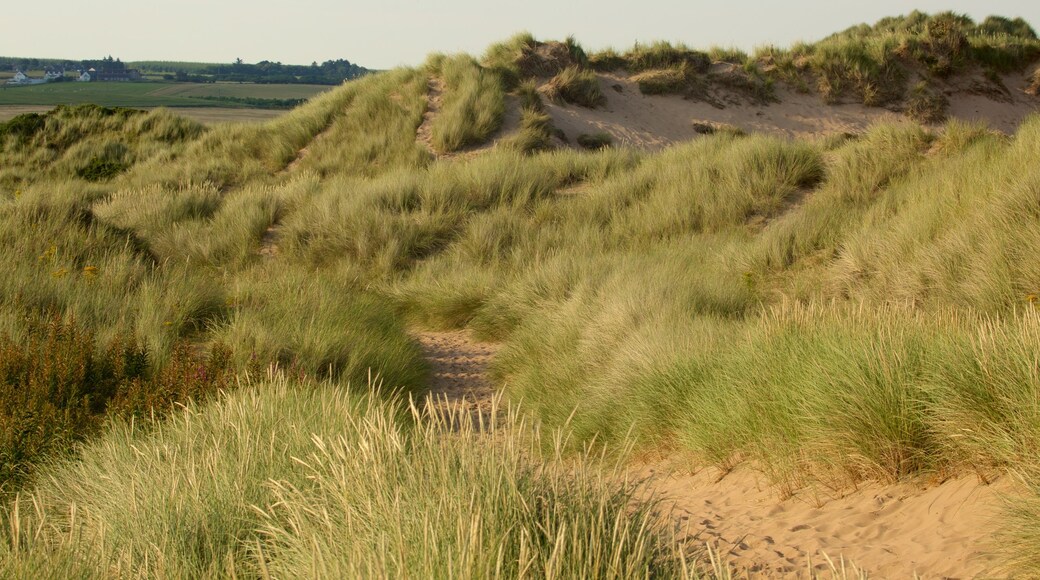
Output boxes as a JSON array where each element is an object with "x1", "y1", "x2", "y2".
[{"x1": 0, "y1": 82, "x2": 332, "y2": 108}]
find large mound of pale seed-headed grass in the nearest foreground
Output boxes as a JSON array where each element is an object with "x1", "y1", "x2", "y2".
[{"x1": 0, "y1": 376, "x2": 682, "y2": 578}]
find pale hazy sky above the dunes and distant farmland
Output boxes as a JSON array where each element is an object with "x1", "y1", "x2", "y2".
[{"x1": 0, "y1": 0, "x2": 1040, "y2": 69}]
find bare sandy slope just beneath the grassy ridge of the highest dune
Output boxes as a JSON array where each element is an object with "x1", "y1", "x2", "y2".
[{"x1": 547, "y1": 73, "x2": 1040, "y2": 149}]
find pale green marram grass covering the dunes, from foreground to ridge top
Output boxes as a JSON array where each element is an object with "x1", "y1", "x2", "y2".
[{"x1": 0, "y1": 10, "x2": 1040, "y2": 577}]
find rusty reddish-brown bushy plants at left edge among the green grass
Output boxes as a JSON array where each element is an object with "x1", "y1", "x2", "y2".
[{"x1": 0, "y1": 316, "x2": 232, "y2": 492}]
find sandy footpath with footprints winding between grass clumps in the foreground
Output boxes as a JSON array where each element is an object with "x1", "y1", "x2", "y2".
[{"x1": 414, "y1": 331, "x2": 1011, "y2": 578}]
